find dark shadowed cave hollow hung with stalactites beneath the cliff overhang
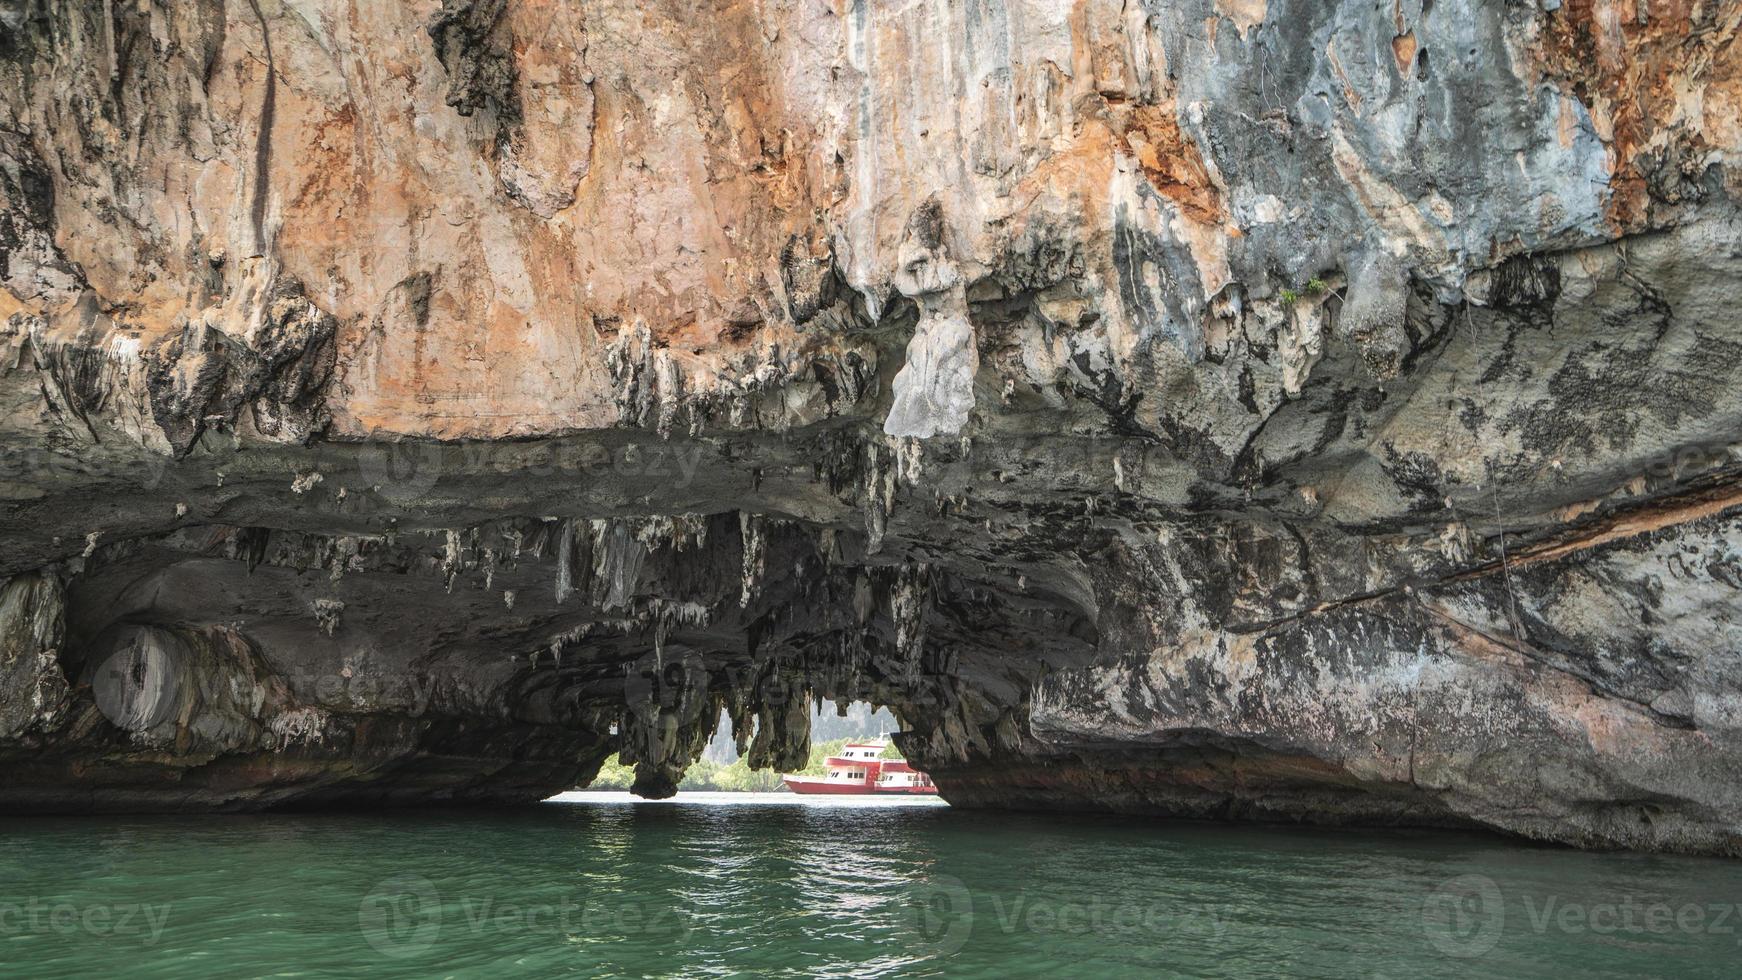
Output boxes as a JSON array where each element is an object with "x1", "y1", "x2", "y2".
[{"x1": 9, "y1": 494, "x2": 1097, "y2": 809}]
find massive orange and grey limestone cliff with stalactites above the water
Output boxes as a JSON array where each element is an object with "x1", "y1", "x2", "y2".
[{"x1": 0, "y1": 0, "x2": 1742, "y2": 853}]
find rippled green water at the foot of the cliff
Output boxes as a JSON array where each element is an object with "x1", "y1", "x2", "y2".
[{"x1": 0, "y1": 794, "x2": 1742, "y2": 978}]
